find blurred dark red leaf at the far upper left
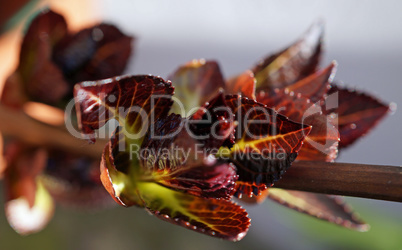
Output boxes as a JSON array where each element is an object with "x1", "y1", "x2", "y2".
[{"x1": 2, "y1": 10, "x2": 68, "y2": 108}]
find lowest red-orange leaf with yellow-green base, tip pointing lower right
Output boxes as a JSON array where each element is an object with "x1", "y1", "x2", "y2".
[{"x1": 102, "y1": 151, "x2": 250, "y2": 241}]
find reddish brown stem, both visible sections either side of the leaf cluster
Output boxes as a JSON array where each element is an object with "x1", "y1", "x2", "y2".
[{"x1": 0, "y1": 105, "x2": 402, "y2": 202}]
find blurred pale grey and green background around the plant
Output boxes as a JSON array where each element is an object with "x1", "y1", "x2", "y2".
[{"x1": 0, "y1": 0, "x2": 402, "y2": 249}]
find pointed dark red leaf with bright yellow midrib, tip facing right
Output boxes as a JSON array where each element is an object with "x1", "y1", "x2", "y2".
[{"x1": 222, "y1": 96, "x2": 311, "y2": 197}]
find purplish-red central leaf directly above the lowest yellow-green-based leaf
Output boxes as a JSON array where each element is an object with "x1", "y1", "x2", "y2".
[{"x1": 140, "y1": 114, "x2": 237, "y2": 199}]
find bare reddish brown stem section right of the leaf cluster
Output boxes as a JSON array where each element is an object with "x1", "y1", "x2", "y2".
[{"x1": 275, "y1": 161, "x2": 402, "y2": 202}]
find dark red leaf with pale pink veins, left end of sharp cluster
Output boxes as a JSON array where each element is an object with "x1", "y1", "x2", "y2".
[{"x1": 74, "y1": 75, "x2": 174, "y2": 141}]
